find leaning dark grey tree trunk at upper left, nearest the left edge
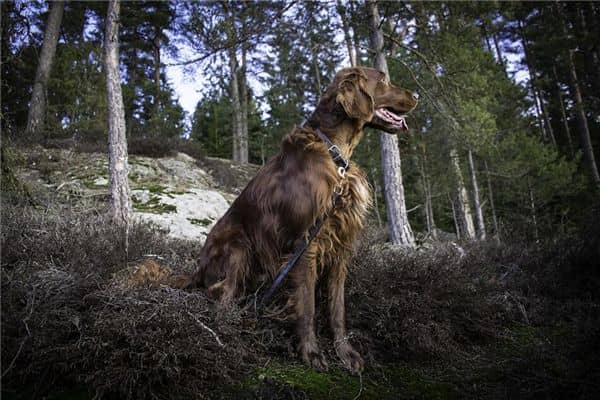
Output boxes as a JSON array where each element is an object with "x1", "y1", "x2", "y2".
[{"x1": 26, "y1": 1, "x2": 65, "y2": 135}]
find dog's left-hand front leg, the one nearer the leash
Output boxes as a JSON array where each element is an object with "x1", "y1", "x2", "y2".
[{"x1": 293, "y1": 250, "x2": 328, "y2": 371}]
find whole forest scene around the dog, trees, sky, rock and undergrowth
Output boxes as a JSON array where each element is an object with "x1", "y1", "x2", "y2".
[{"x1": 0, "y1": 0, "x2": 600, "y2": 399}]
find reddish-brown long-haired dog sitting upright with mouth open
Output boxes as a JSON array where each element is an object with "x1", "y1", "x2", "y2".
[{"x1": 192, "y1": 68, "x2": 417, "y2": 372}]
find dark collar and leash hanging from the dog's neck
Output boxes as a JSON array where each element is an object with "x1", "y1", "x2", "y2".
[{"x1": 258, "y1": 128, "x2": 350, "y2": 313}]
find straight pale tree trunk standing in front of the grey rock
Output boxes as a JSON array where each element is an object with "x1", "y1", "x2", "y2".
[{"x1": 104, "y1": 0, "x2": 131, "y2": 227}]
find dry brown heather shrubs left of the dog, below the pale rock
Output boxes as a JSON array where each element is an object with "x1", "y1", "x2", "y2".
[{"x1": 2, "y1": 208, "x2": 256, "y2": 398}]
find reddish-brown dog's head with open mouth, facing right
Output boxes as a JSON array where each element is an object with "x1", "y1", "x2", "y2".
[{"x1": 333, "y1": 68, "x2": 418, "y2": 133}]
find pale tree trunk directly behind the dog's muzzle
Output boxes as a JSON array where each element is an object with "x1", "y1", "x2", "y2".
[{"x1": 367, "y1": 0, "x2": 415, "y2": 247}]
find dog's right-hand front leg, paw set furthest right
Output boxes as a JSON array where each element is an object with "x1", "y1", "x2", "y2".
[{"x1": 327, "y1": 259, "x2": 364, "y2": 373}]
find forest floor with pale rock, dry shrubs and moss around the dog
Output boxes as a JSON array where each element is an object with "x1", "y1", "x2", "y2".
[{"x1": 2, "y1": 146, "x2": 600, "y2": 399}]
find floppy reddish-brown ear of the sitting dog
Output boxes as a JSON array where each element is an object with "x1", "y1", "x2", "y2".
[{"x1": 336, "y1": 68, "x2": 375, "y2": 121}]
